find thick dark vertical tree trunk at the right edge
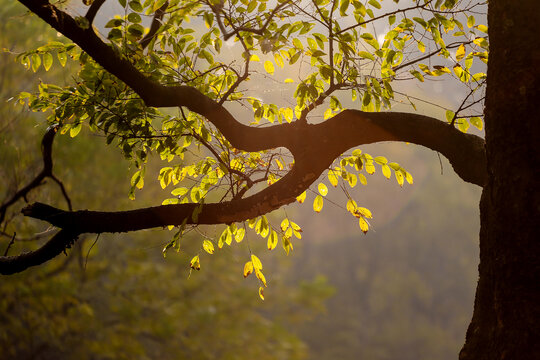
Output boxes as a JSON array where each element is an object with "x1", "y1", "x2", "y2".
[{"x1": 460, "y1": 0, "x2": 540, "y2": 360}]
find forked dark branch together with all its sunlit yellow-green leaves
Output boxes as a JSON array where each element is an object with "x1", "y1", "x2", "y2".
[{"x1": 0, "y1": 0, "x2": 488, "y2": 288}]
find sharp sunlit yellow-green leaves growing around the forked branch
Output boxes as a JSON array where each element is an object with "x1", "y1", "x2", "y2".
[{"x1": 6, "y1": 0, "x2": 488, "y2": 292}]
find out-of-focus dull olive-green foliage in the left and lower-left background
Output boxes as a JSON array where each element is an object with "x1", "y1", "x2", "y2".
[{"x1": 0, "y1": 3, "x2": 331, "y2": 359}]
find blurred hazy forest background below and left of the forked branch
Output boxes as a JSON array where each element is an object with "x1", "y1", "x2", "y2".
[{"x1": 0, "y1": 0, "x2": 480, "y2": 360}]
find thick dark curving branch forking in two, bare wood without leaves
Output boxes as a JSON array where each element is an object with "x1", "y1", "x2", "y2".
[{"x1": 4, "y1": 0, "x2": 487, "y2": 273}]
